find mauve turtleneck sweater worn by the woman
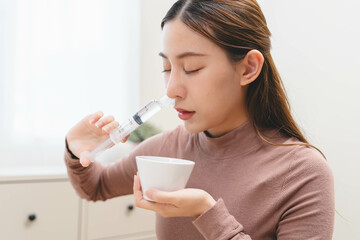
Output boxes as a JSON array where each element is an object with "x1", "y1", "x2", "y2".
[{"x1": 65, "y1": 122, "x2": 334, "y2": 240}]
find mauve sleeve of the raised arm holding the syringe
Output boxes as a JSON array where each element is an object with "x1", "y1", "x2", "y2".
[{"x1": 64, "y1": 134, "x2": 163, "y2": 201}]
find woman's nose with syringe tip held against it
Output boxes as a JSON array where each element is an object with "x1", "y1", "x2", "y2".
[{"x1": 165, "y1": 71, "x2": 186, "y2": 99}]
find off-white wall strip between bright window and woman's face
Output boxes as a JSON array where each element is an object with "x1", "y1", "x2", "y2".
[{"x1": 140, "y1": 0, "x2": 181, "y2": 130}]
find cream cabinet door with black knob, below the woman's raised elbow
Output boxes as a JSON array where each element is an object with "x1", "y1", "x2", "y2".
[{"x1": 84, "y1": 195, "x2": 156, "y2": 240}]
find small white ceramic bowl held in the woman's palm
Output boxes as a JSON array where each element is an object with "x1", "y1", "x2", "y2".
[{"x1": 136, "y1": 156, "x2": 195, "y2": 201}]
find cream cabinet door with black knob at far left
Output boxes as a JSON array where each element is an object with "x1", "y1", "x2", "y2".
[{"x1": 0, "y1": 181, "x2": 80, "y2": 240}]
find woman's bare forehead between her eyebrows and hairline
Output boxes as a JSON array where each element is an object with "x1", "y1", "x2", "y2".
[{"x1": 162, "y1": 19, "x2": 222, "y2": 57}]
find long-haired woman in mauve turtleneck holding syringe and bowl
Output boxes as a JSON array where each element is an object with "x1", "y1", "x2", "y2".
[{"x1": 65, "y1": 0, "x2": 334, "y2": 240}]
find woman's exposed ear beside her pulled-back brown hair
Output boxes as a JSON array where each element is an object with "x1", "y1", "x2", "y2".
[{"x1": 238, "y1": 49, "x2": 264, "y2": 86}]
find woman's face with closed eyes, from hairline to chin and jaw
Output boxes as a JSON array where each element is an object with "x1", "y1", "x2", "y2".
[{"x1": 160, "y1": 19, "x2": 247, "y2": 136}]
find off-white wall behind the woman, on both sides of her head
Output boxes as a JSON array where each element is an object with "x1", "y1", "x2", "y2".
[{"x1": 140, "y1": 0, "x2": 360, "y2": 240}]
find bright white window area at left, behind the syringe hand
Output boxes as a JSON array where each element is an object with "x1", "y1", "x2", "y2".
[{"x1": 0, "y1": 0, "x2": 140, "y2": 169}]
